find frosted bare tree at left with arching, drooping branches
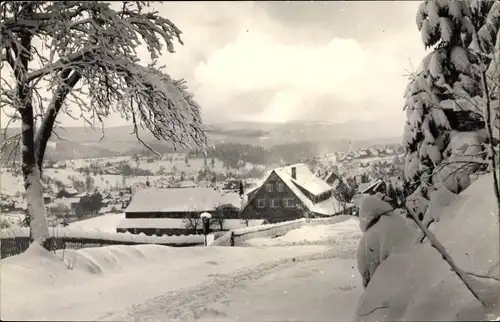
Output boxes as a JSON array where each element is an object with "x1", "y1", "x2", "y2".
[{"x1": 0, "y1": 1, "x2": 206, "y2": 248}]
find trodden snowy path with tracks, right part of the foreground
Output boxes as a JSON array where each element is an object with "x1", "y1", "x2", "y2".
[{"x1": 101, "y1": 220, "x2": 363, "y2": 321}]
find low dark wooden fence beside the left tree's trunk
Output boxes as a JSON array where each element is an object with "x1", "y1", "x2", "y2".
[{"x1": 0, "y1": 237, "x2": 203, "y2": 258}]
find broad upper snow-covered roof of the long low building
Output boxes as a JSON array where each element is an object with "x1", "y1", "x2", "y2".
[{"x1": 125, "y1": 187, "x2": 241, "y2": 212}]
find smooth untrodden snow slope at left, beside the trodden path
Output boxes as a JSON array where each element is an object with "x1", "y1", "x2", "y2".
[{"x1": 0, "y1": 245, "x2": 332, "y2": 321}]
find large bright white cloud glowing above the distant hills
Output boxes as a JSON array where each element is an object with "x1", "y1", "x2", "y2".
[{"x1": 194, "y1": 24, "x2": 423, "y2": 122}]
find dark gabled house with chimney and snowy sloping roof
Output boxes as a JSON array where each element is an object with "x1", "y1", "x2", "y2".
[{"x1": 241, "y1": 163, "x2": 342, "y2": 223}]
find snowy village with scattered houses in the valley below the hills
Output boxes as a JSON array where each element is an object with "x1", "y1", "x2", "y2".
[{"x1": 0, "y1": 148, "x2": 404, "y2": 236}]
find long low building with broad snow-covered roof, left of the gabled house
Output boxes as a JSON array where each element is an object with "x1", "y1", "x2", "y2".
[{"x1": 116, "y1": 187, "x2": 256, "y2": 236}]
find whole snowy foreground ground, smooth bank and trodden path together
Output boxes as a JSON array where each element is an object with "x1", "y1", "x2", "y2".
[{"x1": 0, "y1": 220, "x2": 362, "y2": 321}]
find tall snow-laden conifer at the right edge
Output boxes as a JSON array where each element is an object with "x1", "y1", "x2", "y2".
[{"x1": 404, "y1": 0, "x2": 500, "y2": 192}]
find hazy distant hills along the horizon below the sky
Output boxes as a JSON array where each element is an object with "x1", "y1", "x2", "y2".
[{"x1": 0, "y1": 122, "x2": 400, "y2": 159}]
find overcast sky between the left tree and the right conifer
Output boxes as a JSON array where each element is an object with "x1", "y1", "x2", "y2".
[{"x1": 1, "y1": 1, "x2": 424, "y2": 134}]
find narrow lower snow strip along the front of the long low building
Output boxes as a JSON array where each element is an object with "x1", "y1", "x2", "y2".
[{"x1": 116, "y1": 218, "x2": 265, "y2": 230}]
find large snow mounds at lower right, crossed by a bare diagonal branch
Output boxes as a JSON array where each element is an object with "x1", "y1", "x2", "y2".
[{"x1": 355, "y1": 174, "x2": 500, "y2": 321}]
